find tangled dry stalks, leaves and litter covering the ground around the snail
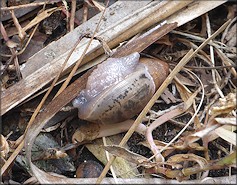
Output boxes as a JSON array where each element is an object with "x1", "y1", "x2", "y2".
[{"x1": 0, "y1": 0, "x2": 237, "y2": 184}]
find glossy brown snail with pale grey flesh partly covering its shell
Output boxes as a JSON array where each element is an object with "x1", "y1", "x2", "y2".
[{"x1": 72, "y1": 52, "x2": 169, "y2": 123}]
